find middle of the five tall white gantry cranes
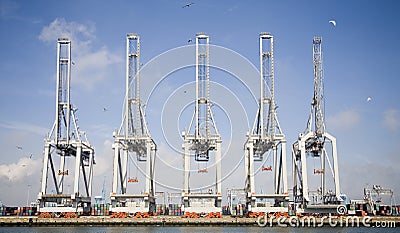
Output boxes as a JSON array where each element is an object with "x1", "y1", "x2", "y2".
[{"x1": 182, "y1": 33, "x2": 222, "y2": 213}]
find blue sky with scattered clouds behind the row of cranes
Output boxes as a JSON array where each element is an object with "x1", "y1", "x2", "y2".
[{"x1": 0, "y1": 0, "x2": 400, "y2": 205}]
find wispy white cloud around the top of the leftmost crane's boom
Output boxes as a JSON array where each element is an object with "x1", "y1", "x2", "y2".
[{"x1": 38, "y1": 18, "x2": 123, "y2": 90}]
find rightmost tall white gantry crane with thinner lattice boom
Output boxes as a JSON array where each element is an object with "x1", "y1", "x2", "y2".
[{"x1": 293, "y1": 37, "x2": 342, "y2": 213}]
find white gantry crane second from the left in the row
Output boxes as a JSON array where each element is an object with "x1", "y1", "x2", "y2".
[{"x1": 110, "y1": 34, "x2": 157, "y2": 214}]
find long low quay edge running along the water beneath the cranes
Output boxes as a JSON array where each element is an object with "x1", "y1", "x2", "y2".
[{"x1": 0, "y1": 216, "x2": 400, "y2": 228}]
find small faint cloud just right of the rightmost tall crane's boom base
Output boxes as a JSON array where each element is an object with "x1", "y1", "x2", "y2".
[{"x1": 326, "y1": 110, "x2": 361, "y2": 130}]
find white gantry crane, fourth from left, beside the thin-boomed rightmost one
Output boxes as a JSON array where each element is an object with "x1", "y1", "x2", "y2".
[{"x1": 244, "y1": 33, "x2": 289, "y2": 212}]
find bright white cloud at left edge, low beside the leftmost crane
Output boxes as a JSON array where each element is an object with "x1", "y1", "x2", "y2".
[{"x1": 0, "y1": 157, "x2": 42, "y2": 182}]
